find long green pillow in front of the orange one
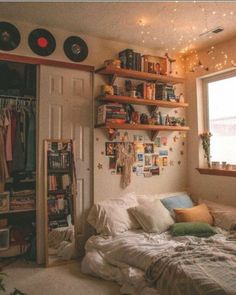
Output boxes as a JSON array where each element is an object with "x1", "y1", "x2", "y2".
[{"x1": 171, "y1": 222, "x2": 217, "y2": 237}]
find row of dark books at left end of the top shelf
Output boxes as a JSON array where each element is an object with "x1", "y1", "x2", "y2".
[{"x1": 119, "y1": 49, "x2": 142, "y2": 71}]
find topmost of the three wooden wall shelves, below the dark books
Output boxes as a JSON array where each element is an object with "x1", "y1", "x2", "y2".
[{"x1": 95, "y1": 66, "x2": 184, "y2": 84}]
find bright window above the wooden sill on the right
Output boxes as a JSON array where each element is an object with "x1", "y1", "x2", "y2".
[{"x1": 205, "y1": 71, "x2": 236, "y2": 165}]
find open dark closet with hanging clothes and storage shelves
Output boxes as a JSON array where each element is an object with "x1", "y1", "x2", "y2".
[{"x1": 0, "y1": 61, "x2": 37, "y2": 260}]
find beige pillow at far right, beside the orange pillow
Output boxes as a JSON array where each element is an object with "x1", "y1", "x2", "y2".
[{"x1": 199, "y1": 200, "x2": 236, "y2": 230}]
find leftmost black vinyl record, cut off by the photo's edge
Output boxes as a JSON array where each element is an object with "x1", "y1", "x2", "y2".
[{"x1": 0, "y1": 22, "x2": 20, "y2": 51}]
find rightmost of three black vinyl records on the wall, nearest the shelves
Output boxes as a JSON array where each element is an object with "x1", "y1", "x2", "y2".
[{"x1": 64, "y1": 36, "x2": 88, "y2": 62}]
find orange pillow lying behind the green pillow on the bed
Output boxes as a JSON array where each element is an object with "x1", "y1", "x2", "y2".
[{"x1": 174, "y1": 204, "x2": 213, "y2": 225}]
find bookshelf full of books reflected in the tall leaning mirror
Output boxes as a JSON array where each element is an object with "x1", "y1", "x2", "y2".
[{"x1": 45, "y1": 140, "x2": 75, "y2": 266}]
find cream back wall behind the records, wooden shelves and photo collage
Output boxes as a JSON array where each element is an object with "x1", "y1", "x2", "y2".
[{"x1": 0, "y1": 19, "x2": 187, "y2": 202}]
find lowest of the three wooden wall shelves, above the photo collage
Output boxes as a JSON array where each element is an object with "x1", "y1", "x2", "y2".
[{"x1": 96, "y1": 123, "x2": 189, "y2": 140}]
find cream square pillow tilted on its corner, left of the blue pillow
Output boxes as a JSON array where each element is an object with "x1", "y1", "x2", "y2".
[{"x1": 129, "y1": 200, "x2": 174, "y2": 234}]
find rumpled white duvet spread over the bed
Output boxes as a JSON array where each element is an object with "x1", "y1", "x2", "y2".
[{"x1": 82, "y1": 230, "x2": 234, "y2": 295}]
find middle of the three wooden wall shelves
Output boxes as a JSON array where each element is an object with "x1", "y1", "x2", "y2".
[{"x1": 98, "y1": 95, "x2": 188, "y2": 108}]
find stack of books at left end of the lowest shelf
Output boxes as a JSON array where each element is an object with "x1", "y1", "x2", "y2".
[{"x1": 97, "y1": 103, "x2": 127, "y2": 125}]
